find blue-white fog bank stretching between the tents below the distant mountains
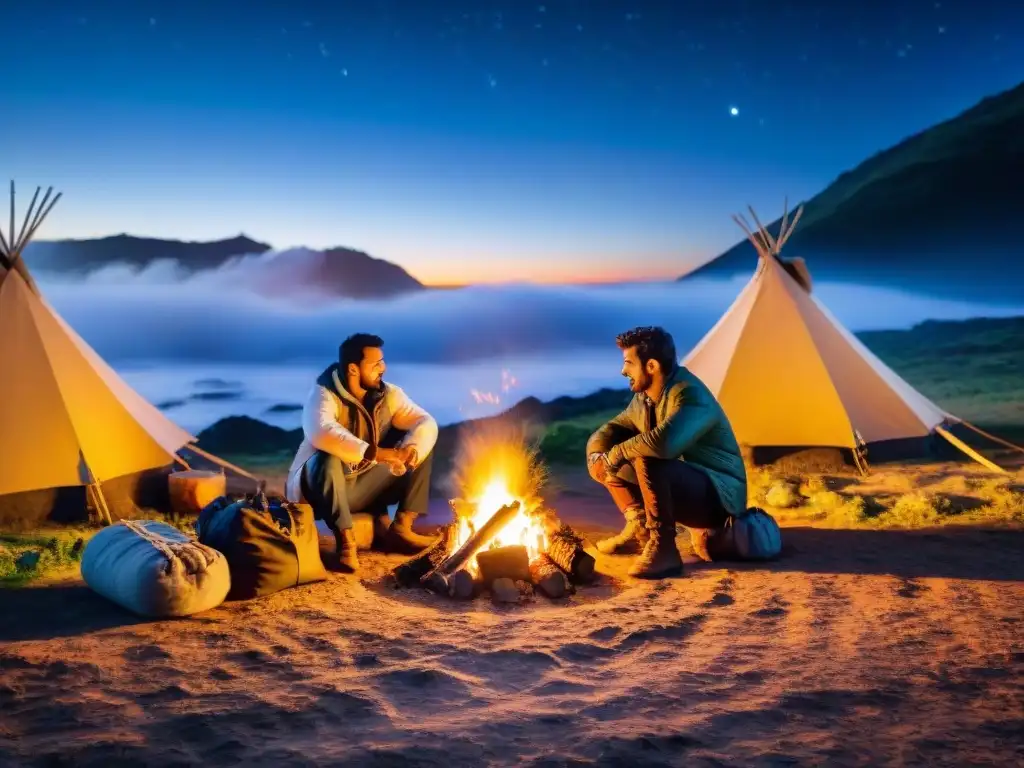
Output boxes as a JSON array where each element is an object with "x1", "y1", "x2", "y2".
[{"x1": 37, "y1": 256, "x2": 1021, "y2": 365}]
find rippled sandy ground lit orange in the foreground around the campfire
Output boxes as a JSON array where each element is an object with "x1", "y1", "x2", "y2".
[{"x1": 0, "y1": 498, "x2": 1024, "y2": 767}]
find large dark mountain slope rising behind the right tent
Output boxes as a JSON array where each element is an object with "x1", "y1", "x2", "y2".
[{"x1": 680, "y1": 83, "x2": 1024, "y2": 301}]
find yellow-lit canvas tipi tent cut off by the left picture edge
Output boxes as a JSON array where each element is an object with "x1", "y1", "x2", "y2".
[{"x1": 0, "y1": 182, "x2": 247, "y2": 525}]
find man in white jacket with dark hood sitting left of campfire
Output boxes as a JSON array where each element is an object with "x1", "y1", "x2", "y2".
[{"x1": 286, "y1": 334, "x2": 437, "y2": 573}]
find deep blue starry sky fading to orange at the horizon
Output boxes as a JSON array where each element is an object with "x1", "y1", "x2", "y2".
[{"x1": 0, "y1": 0, "x2": 1024, "y2": 284}]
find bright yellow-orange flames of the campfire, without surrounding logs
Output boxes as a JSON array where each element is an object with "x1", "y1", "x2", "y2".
[{"x1": 454, "y1": 428, "x2": 547, "y2": 573}]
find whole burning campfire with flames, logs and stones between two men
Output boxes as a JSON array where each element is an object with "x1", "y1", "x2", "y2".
[{"x1": 393, "y1": 427, "x2": 594, "y2": 602}]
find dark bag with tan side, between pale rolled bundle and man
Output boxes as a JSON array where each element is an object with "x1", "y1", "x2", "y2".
[{"x1": 196, "y1": 488, "x2": 327, "y2": 600}]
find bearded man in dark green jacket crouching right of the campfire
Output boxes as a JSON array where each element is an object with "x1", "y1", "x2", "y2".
[{"x1": 587, "y1": 328, "x2": 746, "y2": 579}]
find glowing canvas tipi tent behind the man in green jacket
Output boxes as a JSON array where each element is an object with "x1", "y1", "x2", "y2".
[{"x1": 682, "y1": 198, "x2": 1015, "y2": 469}]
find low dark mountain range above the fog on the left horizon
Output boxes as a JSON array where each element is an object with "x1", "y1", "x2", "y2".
[{"x1": 26, "y1": 234, "x2": 425, "y2": 298}]
